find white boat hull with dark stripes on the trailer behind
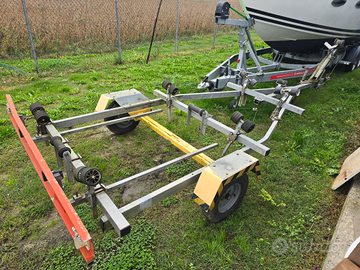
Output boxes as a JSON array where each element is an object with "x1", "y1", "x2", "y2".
[{"x1": 243, "y1": 0, "x2": 360, "y2": 52}]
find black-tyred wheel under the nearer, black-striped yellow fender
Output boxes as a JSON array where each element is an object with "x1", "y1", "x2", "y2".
[{"x1": 201, "y1": 174, "x2": 249, "y2": 223}]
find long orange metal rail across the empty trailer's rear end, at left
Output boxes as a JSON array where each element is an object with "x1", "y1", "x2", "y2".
[{"x1": 6, "y1": 95, "x2": 94, "y2": 263}]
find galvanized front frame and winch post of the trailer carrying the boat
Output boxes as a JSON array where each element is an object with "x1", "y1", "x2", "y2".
[{"x1": 198, "y1": 5, "x2": 343, "y2": 95}]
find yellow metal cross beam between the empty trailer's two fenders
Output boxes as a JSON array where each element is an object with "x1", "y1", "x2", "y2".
[{"x1": 140, "y1": 116, "x2": 214, "y2": 166}]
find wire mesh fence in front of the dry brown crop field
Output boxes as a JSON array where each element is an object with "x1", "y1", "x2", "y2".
[{"x1": 0, "y1": 0, "x2": 241, "y2": 66}]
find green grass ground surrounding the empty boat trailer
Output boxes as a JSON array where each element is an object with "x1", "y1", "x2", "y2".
[{"x1": 0, "y1": 31, "x2": 360, "y2": 269}]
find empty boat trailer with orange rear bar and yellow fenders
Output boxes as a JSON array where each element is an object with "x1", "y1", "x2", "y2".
[{"x1": 6, "y1": 8, "x2": 342, "y2": 263}]
